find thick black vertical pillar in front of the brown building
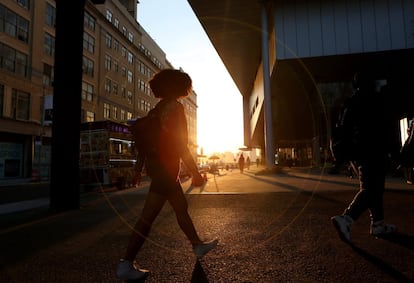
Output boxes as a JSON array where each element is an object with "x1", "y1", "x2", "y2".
[{"x1": 50, "y1": 0, "x2": 86, "y2": 212}]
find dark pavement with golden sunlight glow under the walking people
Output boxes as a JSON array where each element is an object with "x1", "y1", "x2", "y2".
[{"x1": 0, "y1": 166, "x2": 414, "y2": 282}]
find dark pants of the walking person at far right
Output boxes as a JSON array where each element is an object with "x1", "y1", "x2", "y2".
[{"x1": 344, "y1": 160, "x2": 386, "y2": 222}]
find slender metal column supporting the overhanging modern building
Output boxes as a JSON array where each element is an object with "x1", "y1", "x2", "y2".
[{"x1": 261, "y1": 1, "x2": 275, "y2": 168}]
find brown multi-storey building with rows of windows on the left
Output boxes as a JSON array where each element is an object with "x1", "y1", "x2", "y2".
[{"x1": 0, "y1": 0, "x2": 197, "y2": 179}]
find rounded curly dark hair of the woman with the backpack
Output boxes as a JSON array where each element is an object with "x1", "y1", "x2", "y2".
[{"x1": 149, "y1": 69, "x2": 192, "y2": 99}]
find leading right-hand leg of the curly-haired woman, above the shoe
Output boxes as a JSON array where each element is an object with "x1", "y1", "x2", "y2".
[{"x1": 168, "y1": 182, "x2": 203, "y2": 245}]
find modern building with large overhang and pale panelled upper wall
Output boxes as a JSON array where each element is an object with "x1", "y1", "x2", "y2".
[{"x1": 188, "y1": 0, "x2": 414, "y2": 166}]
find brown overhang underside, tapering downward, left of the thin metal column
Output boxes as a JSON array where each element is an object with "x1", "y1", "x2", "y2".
[{"x1": 188, "y1": 0, "x2": 261, "y2": 95}]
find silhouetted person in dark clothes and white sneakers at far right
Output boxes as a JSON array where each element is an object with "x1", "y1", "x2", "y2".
[{"x1": 331, "y1": 73, "x2": 397, "y2": 243}]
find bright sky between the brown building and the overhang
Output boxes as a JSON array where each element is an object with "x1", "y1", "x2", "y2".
[{"x1": 137, "y1": 0, "x2": 243, "y2": 154}]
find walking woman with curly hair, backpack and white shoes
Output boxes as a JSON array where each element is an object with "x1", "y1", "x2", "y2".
[{"x1": 116, "y1": 69, "x2": 217, "y2": 280}]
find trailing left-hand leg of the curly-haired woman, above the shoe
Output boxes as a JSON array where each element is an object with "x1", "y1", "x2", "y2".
[{"x1": 124, "y1": 189, "x2": 166, "y2": 262}]
